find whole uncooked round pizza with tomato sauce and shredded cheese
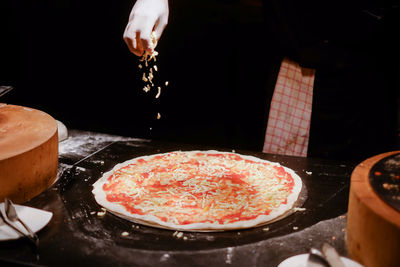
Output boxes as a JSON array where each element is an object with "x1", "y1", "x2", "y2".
[{"x1": 92, "y1": 150, "x2": 302, "y2": 231}]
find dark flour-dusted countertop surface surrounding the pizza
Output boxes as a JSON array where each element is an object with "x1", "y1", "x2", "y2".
[{"x1": 0, "y1": 131, "x2": 355, "y2": 266}]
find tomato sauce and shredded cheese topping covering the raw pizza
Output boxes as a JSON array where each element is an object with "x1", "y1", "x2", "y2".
[{"x1": 103, "y1": 151, "x2": 301, "y2": 228}]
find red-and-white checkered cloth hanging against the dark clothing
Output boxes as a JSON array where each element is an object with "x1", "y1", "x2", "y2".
[{"x1": 263, "y1": 58, "x2": 315, "y2": 157}]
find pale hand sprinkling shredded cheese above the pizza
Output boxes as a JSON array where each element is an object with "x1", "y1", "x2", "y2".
[{"x1": 124, "y1": 0, "x2": 169, "y2": 56}]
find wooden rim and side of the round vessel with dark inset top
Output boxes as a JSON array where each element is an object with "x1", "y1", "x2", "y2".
[{"x1": 346, "y1": 151, "x2": 400, "y2": 267}]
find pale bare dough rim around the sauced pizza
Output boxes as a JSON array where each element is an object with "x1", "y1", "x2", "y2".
[{"x1": 92, "y1": 150, "x2": 302, "y2": 231}]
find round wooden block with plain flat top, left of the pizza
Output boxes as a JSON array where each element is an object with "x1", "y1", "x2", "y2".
[{"x1": 0, "y1": 103, "x2": 58, "y2": 203}]
